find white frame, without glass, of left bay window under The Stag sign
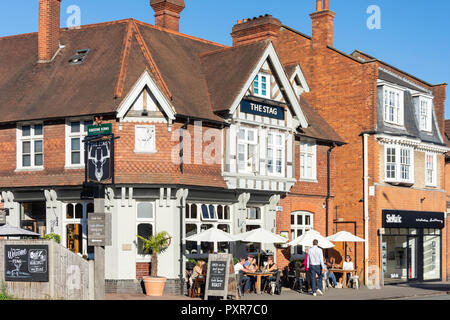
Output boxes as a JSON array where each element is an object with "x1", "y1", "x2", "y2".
[{"x1": 236, "y1": 127, "x2": 259, "y2": 174}]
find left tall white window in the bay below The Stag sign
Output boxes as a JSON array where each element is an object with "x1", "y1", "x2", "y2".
[{"x1": 238, "y1": 128, "x2": 258, "y2": 173}]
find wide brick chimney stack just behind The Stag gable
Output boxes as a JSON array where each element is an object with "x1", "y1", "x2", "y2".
[{"x1": 231, "y1": 14, "x2": 282, "y2": 47}]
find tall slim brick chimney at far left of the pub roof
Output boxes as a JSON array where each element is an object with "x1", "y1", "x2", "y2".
[{"x1": 38, "y1": 0, "x2": 61, "y2": 63}]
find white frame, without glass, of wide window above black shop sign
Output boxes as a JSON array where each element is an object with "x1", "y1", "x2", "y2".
[{"x1": 384, "y1": 145, "x2": 414, "y2": 183}]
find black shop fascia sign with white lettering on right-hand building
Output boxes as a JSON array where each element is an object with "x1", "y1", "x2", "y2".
[{"x1": 383, "y1": 210, "x2": 445, "y2": 229}]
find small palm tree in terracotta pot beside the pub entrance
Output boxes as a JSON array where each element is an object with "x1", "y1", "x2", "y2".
[{"x1": 137, "y1": 231, "x2": 172, "y2": 296}]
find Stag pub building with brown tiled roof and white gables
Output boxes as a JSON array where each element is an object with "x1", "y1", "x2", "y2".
[{"x1": 0, "y1": 0, "x2": 344, "y2": 293}]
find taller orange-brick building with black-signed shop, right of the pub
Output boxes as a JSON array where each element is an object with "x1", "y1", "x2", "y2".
[{"x1": 232, "y1": 0, "x2": 449, "y2": 283}]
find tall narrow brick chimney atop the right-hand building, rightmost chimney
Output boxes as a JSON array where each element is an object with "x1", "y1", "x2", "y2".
[{"x1": 310, "y1": 0, "x2": 336, "y2": 47}]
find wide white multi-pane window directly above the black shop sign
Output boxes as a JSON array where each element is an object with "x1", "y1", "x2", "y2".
[{"x1": 385, "y1": 146, "x2": 414, "y2": 183}]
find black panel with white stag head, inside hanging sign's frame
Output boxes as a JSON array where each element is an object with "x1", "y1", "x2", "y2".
[{"x1": 87, "y1": 140, "x2": 111, "y2": 182}]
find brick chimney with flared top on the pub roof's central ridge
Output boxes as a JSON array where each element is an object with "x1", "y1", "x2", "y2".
[{"x1": 150, "y1": 0, "x2": 185, "y2": 32}]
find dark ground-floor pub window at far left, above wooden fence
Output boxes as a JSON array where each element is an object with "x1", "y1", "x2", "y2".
[{"x1": 20, "y1": 202, "x2": 46, "y2": 236}]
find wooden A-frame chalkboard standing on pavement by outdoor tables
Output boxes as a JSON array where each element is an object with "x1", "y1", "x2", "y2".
[{"x1": 205, "y1": 253, "x2": 239, "y2": 300}]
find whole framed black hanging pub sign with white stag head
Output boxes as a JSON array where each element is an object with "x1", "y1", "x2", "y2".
[{"x1": 85, "y1": 136, "x2": 114, "y2": 183}]
